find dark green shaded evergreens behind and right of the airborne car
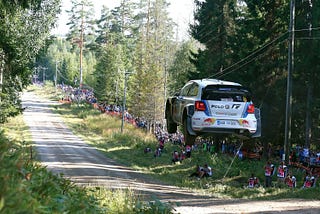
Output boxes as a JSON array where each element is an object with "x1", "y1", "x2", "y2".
[{"x1": 191, "y1": 0, "x2": 320, "y2": 147}]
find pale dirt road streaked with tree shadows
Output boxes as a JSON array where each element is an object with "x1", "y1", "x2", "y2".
[{"x1": 22, "y1": 92, "x2": 320, "y2": 214}]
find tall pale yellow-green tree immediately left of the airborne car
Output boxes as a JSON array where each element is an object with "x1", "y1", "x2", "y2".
[{"x1": 132, "y1": 0, "x2": 173, "y2": 127}]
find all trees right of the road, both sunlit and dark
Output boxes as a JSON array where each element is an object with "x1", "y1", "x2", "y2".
[{"x1": 29, "y1": 0, "x2": 320, "y2": 154}]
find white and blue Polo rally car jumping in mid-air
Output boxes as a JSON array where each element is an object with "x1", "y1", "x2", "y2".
[{"x1": 166, "y1": 79, "x2": 261, "y2": 145}]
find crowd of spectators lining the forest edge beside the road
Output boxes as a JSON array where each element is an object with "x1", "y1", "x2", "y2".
[{"x1": 59, "y1": 85, "x2": 320, "y2": 188}]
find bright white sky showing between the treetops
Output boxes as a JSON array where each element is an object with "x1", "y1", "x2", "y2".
[{"x1": 52, "y1": 0, "x2": 194, "y2": 39}]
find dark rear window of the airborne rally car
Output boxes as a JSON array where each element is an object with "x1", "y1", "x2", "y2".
[{"x1": 201, "y1": 85, "x2": 251, "y2": 102}]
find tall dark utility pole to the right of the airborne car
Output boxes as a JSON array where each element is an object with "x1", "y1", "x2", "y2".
[{"x1": 282, "y1": 0, "x2": 295, "y2": 161}]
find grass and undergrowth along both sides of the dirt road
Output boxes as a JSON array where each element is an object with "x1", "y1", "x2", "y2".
[{"x1": 0, "y1": 85, "x2": 320, "y2": 214}]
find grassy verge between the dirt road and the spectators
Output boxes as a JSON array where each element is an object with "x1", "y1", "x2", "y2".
[{"x1": 34, "y1": 84, "x2": 320, "y2": 199}]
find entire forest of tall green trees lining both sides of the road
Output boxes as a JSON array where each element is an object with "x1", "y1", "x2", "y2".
[{"x1": 0, "y1": 0, "x2": 320, "y2": 151}]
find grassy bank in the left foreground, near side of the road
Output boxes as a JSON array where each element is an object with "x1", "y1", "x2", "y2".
[{"x1": 0, "y1": 84, "x2": 171, "y2": 214}]
